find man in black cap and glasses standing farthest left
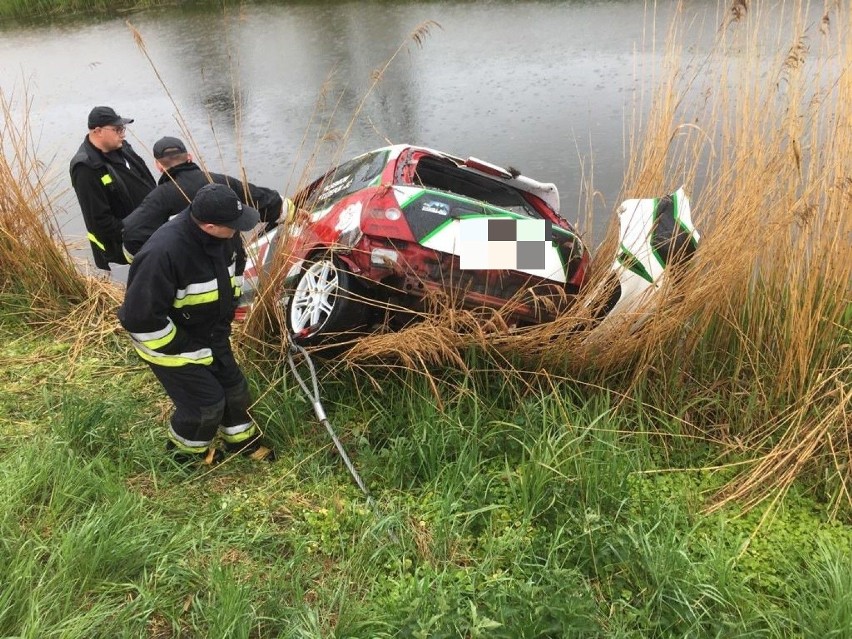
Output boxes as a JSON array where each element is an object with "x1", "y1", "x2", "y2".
[{"x1": 70, "y1": 106, "x2": 156, "y2": 271}]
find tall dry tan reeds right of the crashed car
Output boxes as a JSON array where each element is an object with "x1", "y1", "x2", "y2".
[{"x1": 588, "y1": 2, "x2": 852, "y2": 509}]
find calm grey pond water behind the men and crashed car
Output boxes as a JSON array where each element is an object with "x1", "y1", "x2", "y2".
[{"x1": 0, "y1": 0, "x2": 720, "y2": 272}]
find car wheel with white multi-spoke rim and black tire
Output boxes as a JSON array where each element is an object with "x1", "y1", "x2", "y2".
[{"x1": 285, "y1": 252, "x2": 368, "y2": 350}]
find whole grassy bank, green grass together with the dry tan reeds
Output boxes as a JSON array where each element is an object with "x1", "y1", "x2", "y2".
[{"x1": 0, "y1": 3, "x2": 852, "y2": 638}]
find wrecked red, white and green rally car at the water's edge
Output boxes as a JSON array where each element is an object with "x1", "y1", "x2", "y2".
[{"x1": 238, "y1": 145, "x2": 698, "y2": 346}]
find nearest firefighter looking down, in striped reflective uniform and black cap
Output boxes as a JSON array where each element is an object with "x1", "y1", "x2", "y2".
[{"x1": 118, "y1": 184, "x2": 273, "y2": 464}]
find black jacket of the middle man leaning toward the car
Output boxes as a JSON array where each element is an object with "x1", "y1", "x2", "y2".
[{"x1": 123, "y1": 162, "x2": 282, "y2": 259}]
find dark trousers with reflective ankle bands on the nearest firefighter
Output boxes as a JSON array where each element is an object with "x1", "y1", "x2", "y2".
[{"x1": 149, "y1": 338, "x2": 255, "y2": 453}]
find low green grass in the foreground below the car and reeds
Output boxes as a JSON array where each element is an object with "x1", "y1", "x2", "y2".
[{"x1": 0, "y1": 308, "x2": 852, "y2": 638}]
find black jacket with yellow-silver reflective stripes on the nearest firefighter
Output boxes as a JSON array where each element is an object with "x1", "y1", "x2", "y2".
[{"x1": 118, "y1": 208, "x2": 246, "y2": 366}]
